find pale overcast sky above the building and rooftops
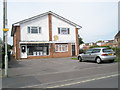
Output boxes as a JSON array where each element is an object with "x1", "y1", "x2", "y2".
[{"x1": 0, "y1": 0, "x2": 118, "y2": 44}]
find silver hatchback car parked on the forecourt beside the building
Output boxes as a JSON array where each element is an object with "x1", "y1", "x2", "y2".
[{"x1": 78, "y1": 47, "x2": 116, "y2": 64}]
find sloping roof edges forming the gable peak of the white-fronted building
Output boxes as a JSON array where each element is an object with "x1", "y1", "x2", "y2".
[{"x1": 13, "y1": 11, "x2": 82, "y2": 28}]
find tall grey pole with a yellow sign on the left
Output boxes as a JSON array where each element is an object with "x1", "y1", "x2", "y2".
[{"x1": 3, "y1": 0, "x2": 8, "y2": 77}]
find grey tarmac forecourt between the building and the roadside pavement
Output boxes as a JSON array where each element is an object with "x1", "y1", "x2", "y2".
[{"x1": 4, "y1": 57, "x2": 116, "y2": 76}]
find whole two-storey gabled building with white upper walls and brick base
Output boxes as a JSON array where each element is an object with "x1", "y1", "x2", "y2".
[{"x1": 11, "y1": 11, "x2": 81, "y2": 59}]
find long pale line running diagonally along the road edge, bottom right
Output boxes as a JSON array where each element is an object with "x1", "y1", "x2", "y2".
[{"x1": 47, "y1": 74, "x2": 120, "y2": 88}]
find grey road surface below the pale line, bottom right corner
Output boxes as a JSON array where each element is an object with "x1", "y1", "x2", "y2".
[{"x1": 58, "y1": 76, "x2": 118, "y2": 88}]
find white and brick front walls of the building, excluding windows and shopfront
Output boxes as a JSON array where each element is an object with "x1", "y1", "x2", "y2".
[{"x1": 14, "y1": 15, "x2": 79, "y2": 59}]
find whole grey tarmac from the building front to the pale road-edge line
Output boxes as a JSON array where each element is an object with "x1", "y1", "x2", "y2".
[{"x1": 2, "y1": 57, "x2": 118, "y2": 88}]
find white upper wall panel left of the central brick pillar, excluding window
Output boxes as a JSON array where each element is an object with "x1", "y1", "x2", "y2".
[{"x1": 20, "y1": 16, "x2": 49, "y2": 41}]
